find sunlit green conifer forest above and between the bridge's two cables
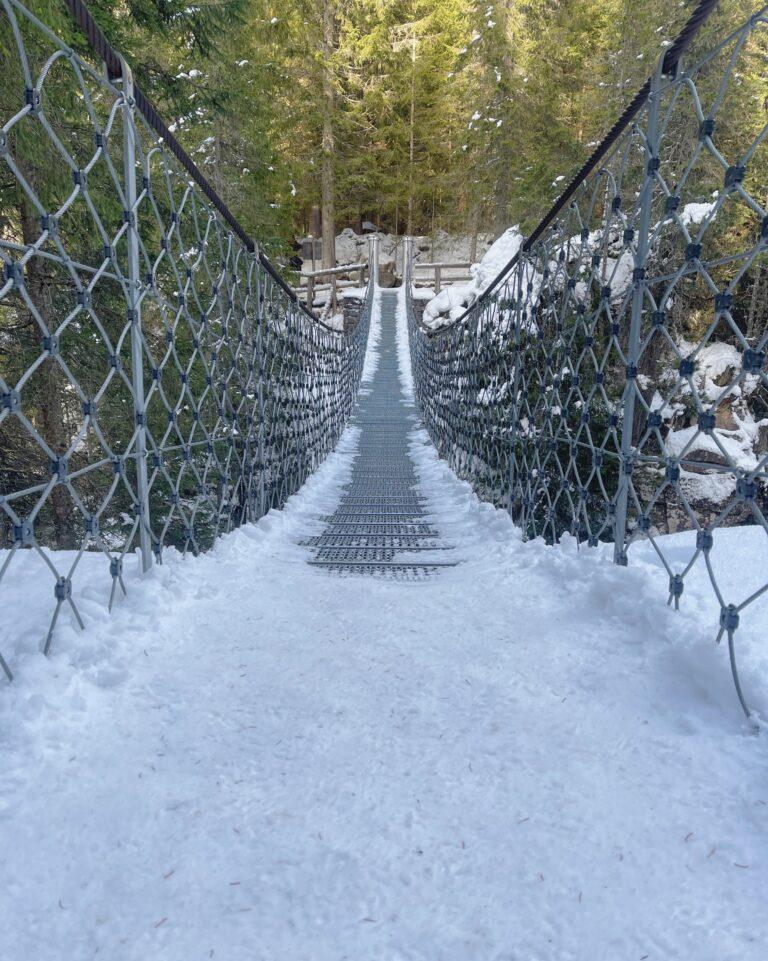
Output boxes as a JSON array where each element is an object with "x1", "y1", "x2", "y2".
[{"x1": 6, "y1": 0, "x2": 756, "y2": 251}]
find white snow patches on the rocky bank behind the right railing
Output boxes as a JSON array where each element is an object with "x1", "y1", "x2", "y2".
[{"x1": 420, "y1": 202, "x2": 768, "y2": 512}]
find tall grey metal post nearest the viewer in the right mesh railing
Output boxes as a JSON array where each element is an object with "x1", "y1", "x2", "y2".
[{"x1": 613, "y1": 55, "x2": 664, "y2": 565}]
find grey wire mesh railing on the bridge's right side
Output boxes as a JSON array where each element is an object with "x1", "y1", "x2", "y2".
[{"x1": 406, "y1": 3, "x2": 768, "y2": 716}]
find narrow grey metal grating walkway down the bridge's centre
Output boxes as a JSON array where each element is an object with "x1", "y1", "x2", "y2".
[{"x1": 304, "y1": 292, "x2": 456, "y2": 580}]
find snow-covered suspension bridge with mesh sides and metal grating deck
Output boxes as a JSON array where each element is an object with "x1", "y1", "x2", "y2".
[{"x1": 0, "y1": 0, "x2": 768, "y2": 961}]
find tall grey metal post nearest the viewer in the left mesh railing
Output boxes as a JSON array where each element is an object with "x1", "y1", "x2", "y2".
[{"x1": 120, "y1": 57, "x2": 152, "y2": 572}]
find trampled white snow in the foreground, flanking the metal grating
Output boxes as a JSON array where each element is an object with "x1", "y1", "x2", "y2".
[{"x1": 0, "y1": 286, "x2": 768, "y2": 961}]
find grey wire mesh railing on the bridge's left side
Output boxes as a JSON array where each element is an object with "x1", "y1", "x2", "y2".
[{"x1": 0, "y1": 0, "x2": 371, "y2": 678}]
